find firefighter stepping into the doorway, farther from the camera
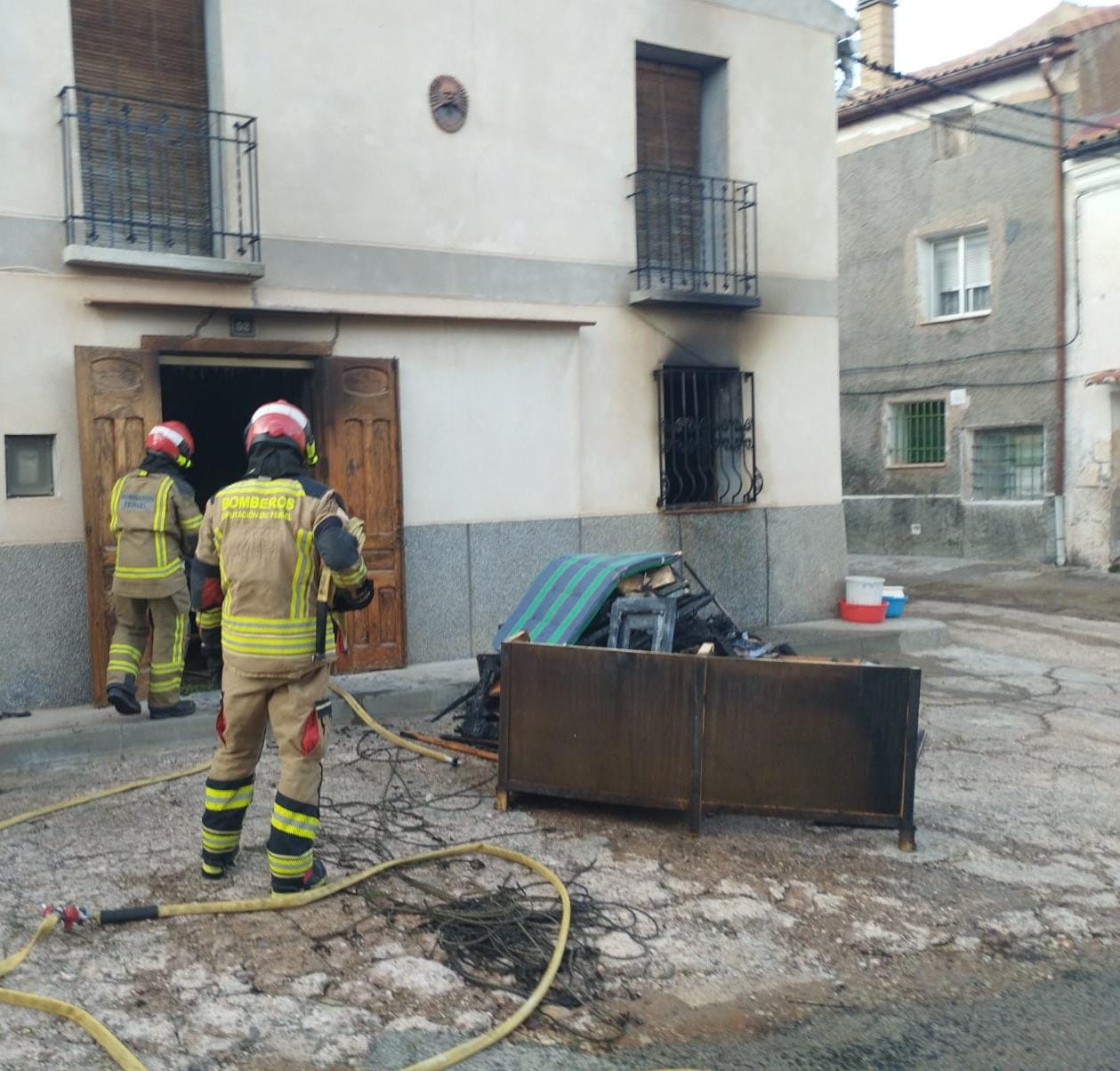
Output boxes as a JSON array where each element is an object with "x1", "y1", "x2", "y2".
[{"x1": 108, "y1": 420, "x2": 203, "y2": 718}]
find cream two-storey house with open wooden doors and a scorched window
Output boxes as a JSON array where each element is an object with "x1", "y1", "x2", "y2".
[{"x1": 0, "y1": 0, "x2": 851, "y2": 709}]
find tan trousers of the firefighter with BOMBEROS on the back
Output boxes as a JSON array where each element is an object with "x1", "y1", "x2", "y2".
[{"x1": 203, "y1": 663, "x2": 330, "y2": 878}]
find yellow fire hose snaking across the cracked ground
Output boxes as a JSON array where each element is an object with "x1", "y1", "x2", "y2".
[{"x1": 0, "y1": 684, "x2": 571, "y2": 1071}]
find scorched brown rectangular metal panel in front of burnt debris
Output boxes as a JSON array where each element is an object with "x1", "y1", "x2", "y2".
[{"x1": 497, "y1": 641, "x2": 922, "y2": 850}]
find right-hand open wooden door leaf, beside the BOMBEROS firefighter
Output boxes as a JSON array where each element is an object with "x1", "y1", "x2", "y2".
[{"x1": 317, "y1": 357, "x2": 405, "y2": 673}]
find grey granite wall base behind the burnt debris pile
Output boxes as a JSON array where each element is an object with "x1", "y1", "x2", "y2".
[{"x1": 404, "y1": 505, "x2": 847, "y2": 663}]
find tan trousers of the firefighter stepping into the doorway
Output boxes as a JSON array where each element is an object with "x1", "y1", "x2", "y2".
[{"x1": 106, "y1": 586, "x2": 190, "y2": 707}]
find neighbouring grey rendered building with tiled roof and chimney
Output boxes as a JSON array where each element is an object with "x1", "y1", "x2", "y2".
[{"x1": 839, "y1": 0, "x2": 1120, "y2": 565}]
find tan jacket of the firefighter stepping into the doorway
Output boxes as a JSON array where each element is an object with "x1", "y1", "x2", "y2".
[{"x1": 109, "y1": 458, "x2": 203, "y2": 598}]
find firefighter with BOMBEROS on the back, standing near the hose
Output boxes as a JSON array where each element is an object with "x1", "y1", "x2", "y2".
[{"x1": 190, "y1": 401, "x2": 373, "y2": 893}]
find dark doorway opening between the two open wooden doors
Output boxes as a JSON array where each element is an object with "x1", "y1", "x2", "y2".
[{"x1": 159, "y1": 357, "x2": 312, "y2": 509}]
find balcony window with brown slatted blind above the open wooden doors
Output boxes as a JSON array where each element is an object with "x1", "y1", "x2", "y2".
[{"x1": 58, "y1": 0, "x2": 260, "y2": 266}]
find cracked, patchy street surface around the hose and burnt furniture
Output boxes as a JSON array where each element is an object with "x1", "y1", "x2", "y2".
[{"x1": 0, "y1": 558, "x2": 1120, "y2": 1071}]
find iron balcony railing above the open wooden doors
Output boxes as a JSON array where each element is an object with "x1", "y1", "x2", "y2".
[{"x1": 58, "y1": 85, "x2": 261, "y2": 262}]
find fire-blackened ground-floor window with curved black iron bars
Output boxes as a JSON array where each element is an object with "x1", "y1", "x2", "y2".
[{"x1": 654, "y1": 366, "x2": 763, "y2": 510}]
